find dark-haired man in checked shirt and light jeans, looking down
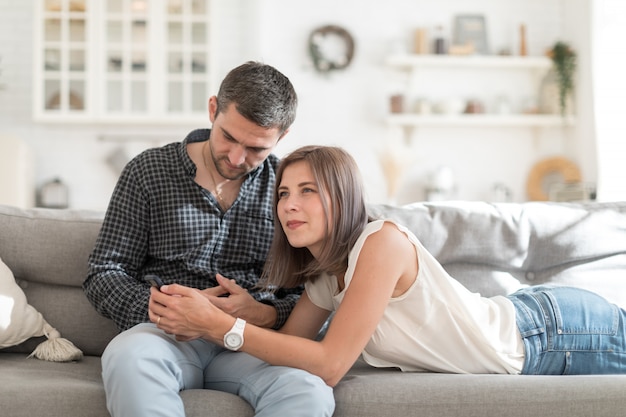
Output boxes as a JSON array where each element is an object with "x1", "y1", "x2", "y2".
[{"x1": 83, "y1": 62, "x2": 334, "y2": 417}]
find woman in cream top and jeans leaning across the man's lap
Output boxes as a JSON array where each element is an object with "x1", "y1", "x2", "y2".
[{"x1": 150, "y1": 146, "x2": 626, "y2": 386}]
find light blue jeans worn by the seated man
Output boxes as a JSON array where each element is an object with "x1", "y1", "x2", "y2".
[{"x1": 102, "y1": 323, "x2": 335, "y2": 417}]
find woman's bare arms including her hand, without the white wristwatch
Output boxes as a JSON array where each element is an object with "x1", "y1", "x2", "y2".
[{"x1": 150, "y1": 223, "x2": 417, "y2": 386}]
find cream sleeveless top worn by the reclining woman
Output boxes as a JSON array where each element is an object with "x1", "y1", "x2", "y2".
[{"x1": 305, "y1": 220, "x2": 524, "y2": 374}]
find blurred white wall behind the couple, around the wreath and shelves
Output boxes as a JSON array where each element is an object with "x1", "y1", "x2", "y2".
[{"x1": 0, "y1": 0, "x2": 597, "y2": 209}]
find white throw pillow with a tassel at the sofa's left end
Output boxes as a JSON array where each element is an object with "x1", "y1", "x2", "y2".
[{"x1": 0, "y1": 255, "x2": 83, "y2": 362}]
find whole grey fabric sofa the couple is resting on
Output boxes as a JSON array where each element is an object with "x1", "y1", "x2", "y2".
[{"x1": 0, "y1": 202, "x2": 626, "y2": 417}]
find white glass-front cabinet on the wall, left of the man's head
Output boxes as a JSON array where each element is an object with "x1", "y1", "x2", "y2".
[{"x1": 34, "y1": 0, "x2": 215, "y2": 122}]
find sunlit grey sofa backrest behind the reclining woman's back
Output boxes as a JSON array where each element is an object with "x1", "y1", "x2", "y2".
[{"x1": 370, "y1": 201, "x2": 626, "y2": 307}]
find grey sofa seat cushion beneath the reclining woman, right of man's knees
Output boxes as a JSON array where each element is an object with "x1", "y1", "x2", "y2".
[{"x1": 334, "y1": 360, "x2": 626, "y2": 417}]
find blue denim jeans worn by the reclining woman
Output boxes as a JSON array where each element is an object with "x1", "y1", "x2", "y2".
[{"x1": 509, "y1": 286, "x2": 626, "y2": 375}]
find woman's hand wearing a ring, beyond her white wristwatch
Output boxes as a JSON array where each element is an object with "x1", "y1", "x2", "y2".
[{"x1": 148, "y1": 284, "x2": 229, "y2": 345}]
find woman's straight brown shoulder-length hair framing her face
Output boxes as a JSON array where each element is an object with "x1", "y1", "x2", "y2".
[{"x1": 261, "y1": 146, "x2": 369, "y2": 290}]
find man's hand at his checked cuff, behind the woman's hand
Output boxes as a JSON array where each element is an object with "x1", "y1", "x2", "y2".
[{"x1": 202, "y1": 274, "x2": 278, "y2": 327}]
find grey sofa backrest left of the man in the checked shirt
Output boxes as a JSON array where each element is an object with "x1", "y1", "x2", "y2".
[{"x1": 0, "y1": 206, "x2": 117, "y2": 355}]
